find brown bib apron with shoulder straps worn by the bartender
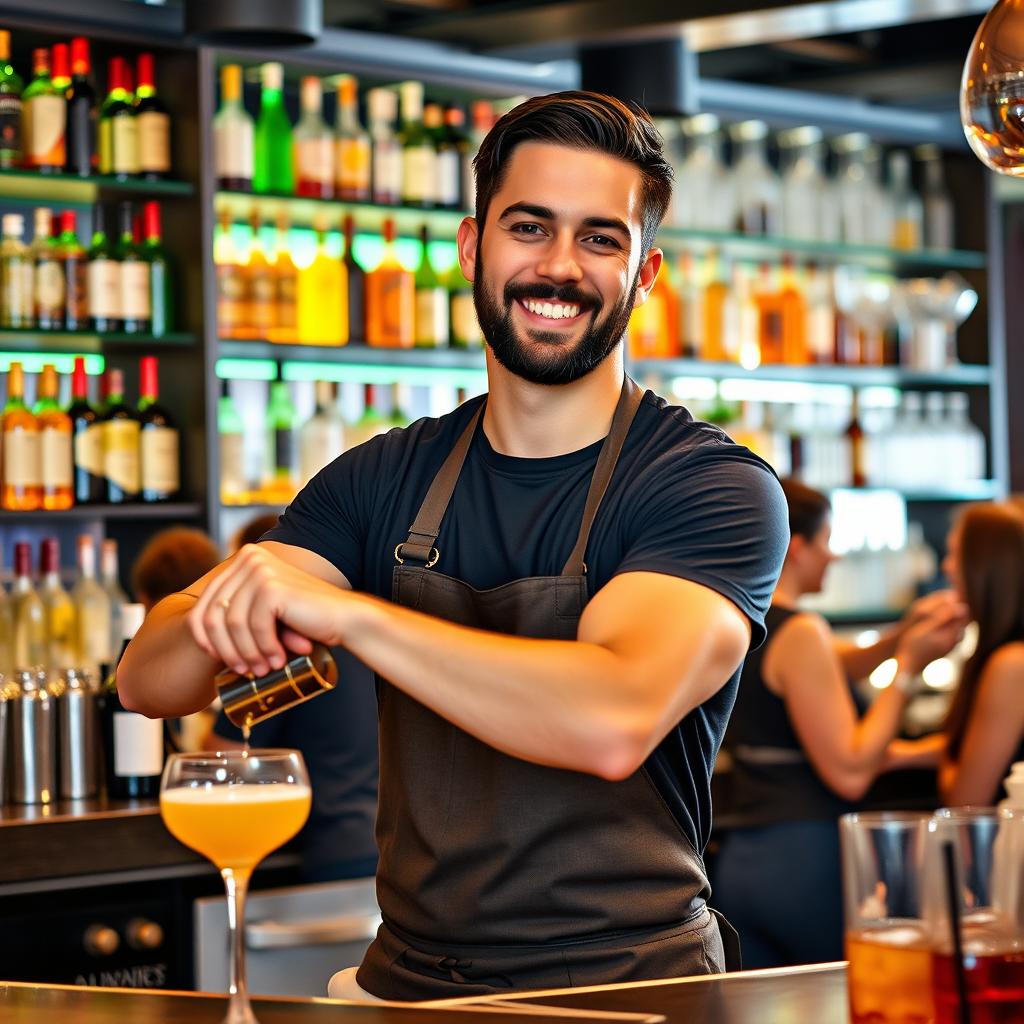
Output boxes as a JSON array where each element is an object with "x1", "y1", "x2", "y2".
[{"x1": 357, "y1": 378, "x2": 738, "y2": 999}]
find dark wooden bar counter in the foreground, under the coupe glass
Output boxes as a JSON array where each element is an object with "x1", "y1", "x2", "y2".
[{"x1": 0, "y1": 964, "x2": 849, "y2": 1024}]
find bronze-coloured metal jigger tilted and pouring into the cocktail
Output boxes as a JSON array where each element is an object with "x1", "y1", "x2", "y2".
[{"x1": 214, "y1": 644, "x2": 338, "y2": 729}]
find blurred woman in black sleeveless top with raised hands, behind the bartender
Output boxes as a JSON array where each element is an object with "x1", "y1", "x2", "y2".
[{"x1": 715, "y1": 480, "x2": 967, "y2": 968}]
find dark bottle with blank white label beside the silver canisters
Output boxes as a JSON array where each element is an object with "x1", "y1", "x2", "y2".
[{"x1": 99, "y1": 604, "x2": 164, "y2": 800}]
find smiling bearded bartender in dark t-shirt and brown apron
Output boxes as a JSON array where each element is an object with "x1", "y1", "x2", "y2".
[{"x1": 118, "y1": 92, "x2": 787, "y2": 999}]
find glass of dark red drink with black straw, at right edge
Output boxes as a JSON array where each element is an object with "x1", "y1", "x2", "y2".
[{"x1": 925, "y1": 807, "x2": 1024, "y2": 1024}]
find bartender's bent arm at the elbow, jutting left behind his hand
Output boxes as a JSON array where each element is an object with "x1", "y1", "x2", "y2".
[{"x1": 118, "y1": 594, "x2": 223, "y2": 718}]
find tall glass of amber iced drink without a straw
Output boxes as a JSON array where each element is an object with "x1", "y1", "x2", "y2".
[{"x1": 840, "y1": 812, "x2": 934, "y2": 1024}]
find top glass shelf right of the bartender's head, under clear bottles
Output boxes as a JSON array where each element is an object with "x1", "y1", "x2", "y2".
[{"x1": 657, "y1": 226, "x2": 987, "y2": 271}]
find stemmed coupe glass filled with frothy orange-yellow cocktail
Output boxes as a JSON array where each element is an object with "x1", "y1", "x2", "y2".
[{"x1": 160, "y1": 750, "x2": 312, "y2": 1024}]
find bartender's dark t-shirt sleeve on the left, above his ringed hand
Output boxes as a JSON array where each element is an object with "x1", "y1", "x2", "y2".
[{"x1": 262, "y1": 437, "x2": 383, "y2": 590}]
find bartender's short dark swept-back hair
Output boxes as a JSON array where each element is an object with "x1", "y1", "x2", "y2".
[{"x1": 473, "y1": 91, "x2": 673, "y2": 252}]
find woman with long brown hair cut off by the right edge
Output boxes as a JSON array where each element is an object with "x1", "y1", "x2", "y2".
[{"x1": 939, "y1": 503, "x2": 1024, "y2": 806}]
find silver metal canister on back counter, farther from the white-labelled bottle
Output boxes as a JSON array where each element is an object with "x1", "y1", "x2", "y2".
[{"x1": 8, "y1": 670, "x2": 57, "y2": 804}]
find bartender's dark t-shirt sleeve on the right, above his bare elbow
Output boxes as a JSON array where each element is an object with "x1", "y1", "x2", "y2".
[{"x1": 616, "y1": 444, "x2": 790, "y2": 649}]
